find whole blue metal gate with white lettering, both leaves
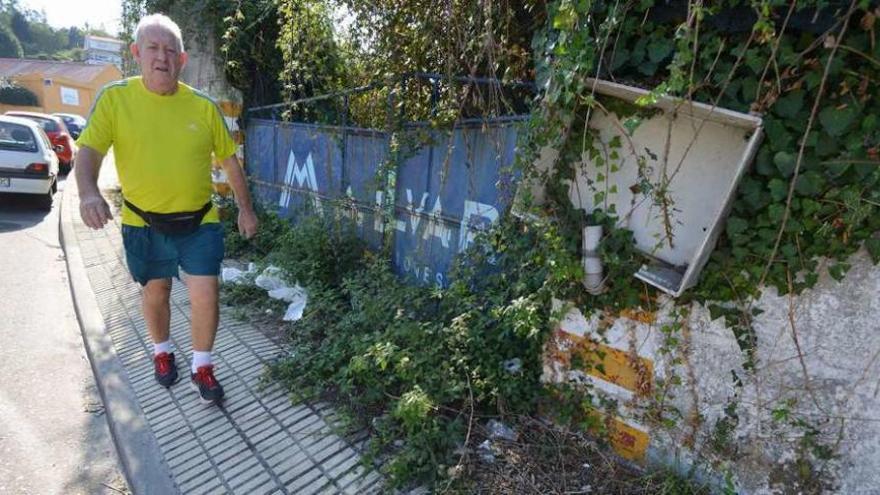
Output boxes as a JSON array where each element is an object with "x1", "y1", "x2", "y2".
[{"x1": 245, "y1": 118, "x2": 519, "y2": 286}]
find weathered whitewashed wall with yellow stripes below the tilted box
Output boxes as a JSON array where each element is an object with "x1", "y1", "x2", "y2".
[{"x1": 545, "y1": 252, "x2": 880, "y2": 494}]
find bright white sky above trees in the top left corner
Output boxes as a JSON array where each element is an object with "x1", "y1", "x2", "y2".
[{"x1": 18, "y1": 0, "x2": 122, "y2": 35}]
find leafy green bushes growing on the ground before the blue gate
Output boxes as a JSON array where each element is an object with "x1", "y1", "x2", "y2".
[{"x1": 224, "y1": 199, "x2": 704, "y2": 494}]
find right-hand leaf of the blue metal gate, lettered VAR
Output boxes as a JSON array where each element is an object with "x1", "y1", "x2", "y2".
[{"x1": 394, "y1": 122, "x2": 517, "y2": 287}]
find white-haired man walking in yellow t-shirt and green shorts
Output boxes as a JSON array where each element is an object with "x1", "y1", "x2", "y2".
[{"x1": 75, "y1": 14, "x2": 257, "y2": 403}]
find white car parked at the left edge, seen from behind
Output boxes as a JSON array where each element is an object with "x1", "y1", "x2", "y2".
[{"x1": 0, "y1": 115, "x2": 58, "y2": 210}]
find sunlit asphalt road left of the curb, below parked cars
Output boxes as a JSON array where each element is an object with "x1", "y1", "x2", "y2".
[{"x1": 0, "y1": 172, "x2": 128, "y2": 495}]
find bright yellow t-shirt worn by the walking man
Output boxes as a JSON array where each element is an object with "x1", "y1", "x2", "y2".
[{"x1": 76, "y1": 77, "x2": 235, "y2": 227}]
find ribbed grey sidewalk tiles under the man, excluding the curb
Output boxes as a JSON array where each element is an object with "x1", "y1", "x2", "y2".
[{"x1": 74, "y1": 213, "x2": 382, "y2": 495}]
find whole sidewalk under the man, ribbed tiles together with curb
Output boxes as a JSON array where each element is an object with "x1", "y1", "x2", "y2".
[{"x1": 62, "y1": 181, "x2": 382, "y2": 495}]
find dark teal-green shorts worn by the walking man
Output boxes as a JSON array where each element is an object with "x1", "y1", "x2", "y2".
[{"x1": 122, "y1": 223, "x2": 223, "y2": 285}]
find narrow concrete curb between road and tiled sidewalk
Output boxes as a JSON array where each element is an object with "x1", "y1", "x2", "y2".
[{"x1": 59, "y1": 178, "x2": 180, "y2": 495}]
